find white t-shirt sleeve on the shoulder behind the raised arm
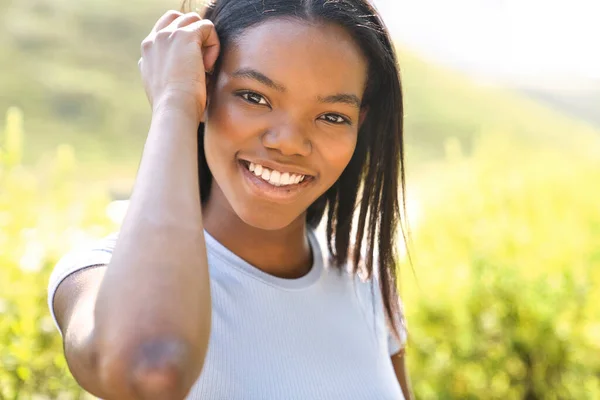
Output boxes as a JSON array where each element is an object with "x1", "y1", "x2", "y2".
[{"x1": 48, "y1": 233, "x2": 118, "y2": 332}]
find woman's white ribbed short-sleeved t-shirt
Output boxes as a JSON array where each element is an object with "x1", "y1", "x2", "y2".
[{"x1": 48, "y1": 228, "x2": 406, "y2": 400}]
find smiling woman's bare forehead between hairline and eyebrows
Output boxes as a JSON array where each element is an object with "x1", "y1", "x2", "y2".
[{"x1": 223, "y1": 18, "x2": 367, "y2": 97}]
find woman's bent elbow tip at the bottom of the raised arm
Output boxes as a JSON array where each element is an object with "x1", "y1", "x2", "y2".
[{"x1": 98, "y1": 339, "x2": 202, "y2": 400}]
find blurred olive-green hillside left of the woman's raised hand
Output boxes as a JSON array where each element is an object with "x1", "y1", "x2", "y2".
[{"x1": 0, "y1": 0, "x2": 169, "y2": 166}]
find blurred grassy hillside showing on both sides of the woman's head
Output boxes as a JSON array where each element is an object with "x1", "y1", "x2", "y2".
[{"x1": 0, "y1": 0, "x2": 600, "y2": 171}]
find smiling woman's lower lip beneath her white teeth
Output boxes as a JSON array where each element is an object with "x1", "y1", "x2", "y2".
[{"x1": 237, "y1": 160, "x2": 315, "y2": 204}]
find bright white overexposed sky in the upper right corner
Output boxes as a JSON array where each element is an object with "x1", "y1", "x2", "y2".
[{"x1": 374, "y1": 0, "x2": 600, "y2": 80}]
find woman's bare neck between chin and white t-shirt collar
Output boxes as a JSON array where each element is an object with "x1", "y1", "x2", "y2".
[{"x1": 202, "y1": 182, "x2": 312, "y2": 279}]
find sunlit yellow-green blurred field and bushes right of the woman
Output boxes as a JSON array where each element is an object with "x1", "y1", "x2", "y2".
[{"x1": 402, "y1": 135, "x2": 600, "y2": 399}]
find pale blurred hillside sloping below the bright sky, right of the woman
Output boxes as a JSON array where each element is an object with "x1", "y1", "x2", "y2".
[{"x1": 400, "y1": 51, "x2": 600, "y2": 161}]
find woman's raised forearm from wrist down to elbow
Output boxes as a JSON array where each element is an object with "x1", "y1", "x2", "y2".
[{"x1": 94, "y1": 101, "x2": 211, "y2": 398}]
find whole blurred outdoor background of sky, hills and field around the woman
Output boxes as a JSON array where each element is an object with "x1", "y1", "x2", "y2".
[{"x1": 0, "y1": 0, "x2": 600, "y2": 400}]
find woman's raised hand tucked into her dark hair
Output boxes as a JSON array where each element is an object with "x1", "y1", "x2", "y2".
[{"x1": 138, "y1": 11, "x2": 220, "y2": 122}]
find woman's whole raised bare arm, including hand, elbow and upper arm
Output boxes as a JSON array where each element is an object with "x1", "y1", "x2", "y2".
[{"x1": 54, "y1": 12, "x2": 218, "y2": 399}]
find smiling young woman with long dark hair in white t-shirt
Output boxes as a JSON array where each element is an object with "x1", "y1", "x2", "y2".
[{"x1": 49, "y1": 0, "x2": 411, "y2": 400}]
